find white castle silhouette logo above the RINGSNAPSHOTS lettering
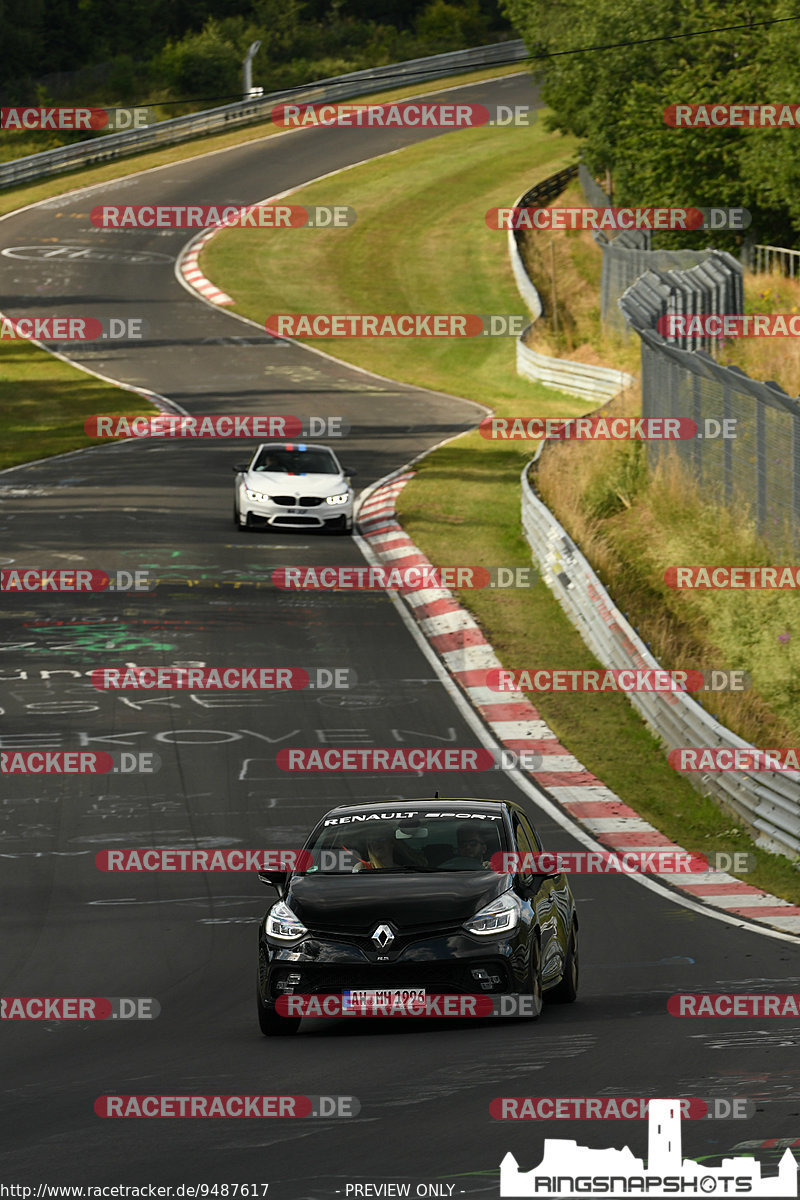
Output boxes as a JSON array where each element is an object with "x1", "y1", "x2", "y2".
[{"x1": 500, "y1": 1099, "x2": 798, "y2": 1200}]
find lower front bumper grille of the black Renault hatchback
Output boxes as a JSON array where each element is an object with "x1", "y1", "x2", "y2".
[{"x1": 270, "y1": 960, "x2": 512, "y2": 996}]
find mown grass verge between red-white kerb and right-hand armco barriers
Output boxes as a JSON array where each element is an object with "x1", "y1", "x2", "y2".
[{"x1": 204, "y1": 114, "x2": 800, "y2": 902}]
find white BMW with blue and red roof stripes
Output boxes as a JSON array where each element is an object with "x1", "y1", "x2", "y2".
[{"x1": 233, "y1": 442, "x2": 354, "y2": 533}]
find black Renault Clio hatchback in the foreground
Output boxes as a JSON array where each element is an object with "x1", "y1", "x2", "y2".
[{"x1": 257, "y1": 799, "x2": 578, "y2": 1036}]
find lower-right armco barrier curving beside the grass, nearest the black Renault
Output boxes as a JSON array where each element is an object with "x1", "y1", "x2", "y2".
[{"x1": 522, "y1": 458, "x2": 800, "y2": 858}]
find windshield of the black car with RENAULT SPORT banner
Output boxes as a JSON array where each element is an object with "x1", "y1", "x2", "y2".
[{"x1": 297, "y1": 810, "x2": 509, "y2": 875}]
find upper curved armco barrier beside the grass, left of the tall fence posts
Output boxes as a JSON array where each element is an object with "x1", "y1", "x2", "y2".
[{"x1": 509, "y1": 167, "x2": 636, "y2": 401}]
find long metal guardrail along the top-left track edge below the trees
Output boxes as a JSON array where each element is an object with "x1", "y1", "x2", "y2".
[{"x1": 0, "y1": 38, "x2": 528, "y2": 188}]
